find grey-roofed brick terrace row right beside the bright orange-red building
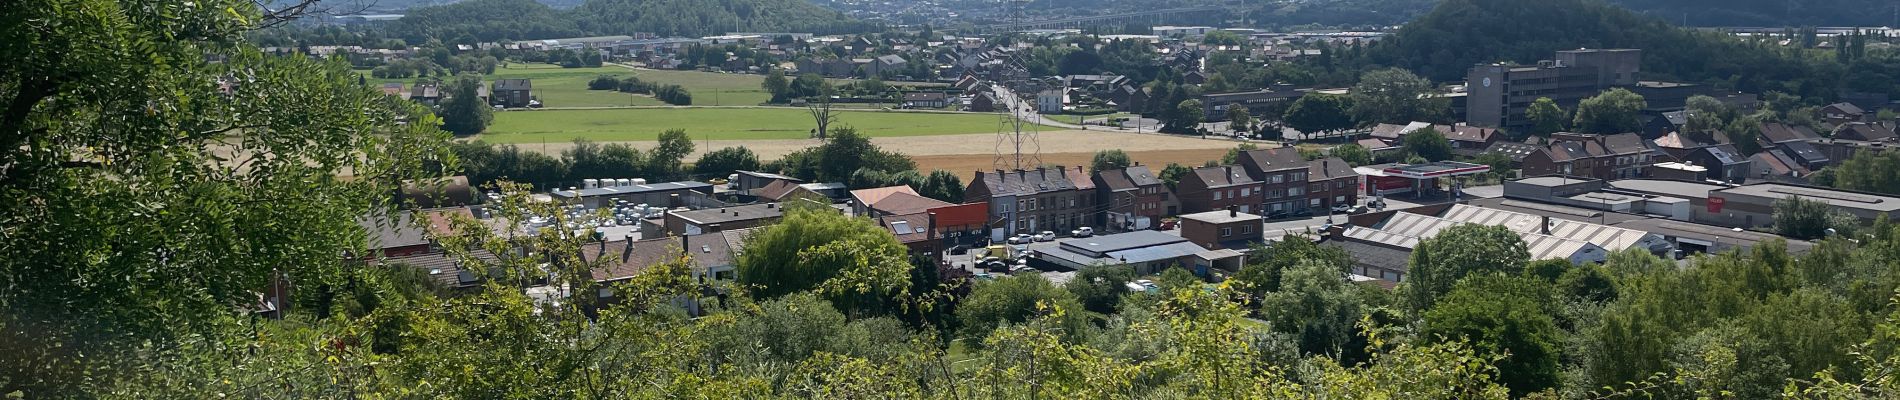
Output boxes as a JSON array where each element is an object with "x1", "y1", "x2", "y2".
[{"x1": 963, "y1": 167, "x2": 1096, "y2": 241}]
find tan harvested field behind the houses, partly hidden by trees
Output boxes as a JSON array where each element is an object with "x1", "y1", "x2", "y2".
[{"x1": 497, "y1": 131, "x2": 1239, "y2": 172}]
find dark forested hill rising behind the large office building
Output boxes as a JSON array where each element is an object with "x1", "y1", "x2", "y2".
[{"x1": 1360, "y1": 0, "x2": 1843, "y2": 97}]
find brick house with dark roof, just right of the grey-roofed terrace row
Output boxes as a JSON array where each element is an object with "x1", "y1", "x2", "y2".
[{"x1": 1094, "y1": 165, "x2": 1176, "y2": 231}]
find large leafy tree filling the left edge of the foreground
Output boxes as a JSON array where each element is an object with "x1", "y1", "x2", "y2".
[{"x1": 0, "y1": 0, "x2": 456, "y2": 398}]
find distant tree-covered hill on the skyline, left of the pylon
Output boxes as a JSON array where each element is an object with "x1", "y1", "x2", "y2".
[{"x1": 391, "y1": 0, "x2": 870, "y2": 44}]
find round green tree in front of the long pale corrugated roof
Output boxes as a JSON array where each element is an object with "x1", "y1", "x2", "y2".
[{"x1": 1406, "y1": 224, "x2": 1531, "y2": 313}]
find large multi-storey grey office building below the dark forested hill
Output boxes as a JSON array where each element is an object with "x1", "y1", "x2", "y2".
[{"x1": 1465, "y1": 49, "x2": 1644, "y2": 129}]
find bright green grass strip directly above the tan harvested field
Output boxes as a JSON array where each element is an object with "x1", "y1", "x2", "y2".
[{"x1": 469, "y1": 108, "x2": 1048, "y2": 142}]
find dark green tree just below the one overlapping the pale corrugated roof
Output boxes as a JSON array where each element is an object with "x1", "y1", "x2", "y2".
[{"x1": 1421, "y1": 275, "x2": 1562, "y2": 396}]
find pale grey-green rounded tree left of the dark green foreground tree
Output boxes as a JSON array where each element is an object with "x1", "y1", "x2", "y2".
[{"x1": 1260, "y1": 260, "x2": 1364, "y2": 355}]
